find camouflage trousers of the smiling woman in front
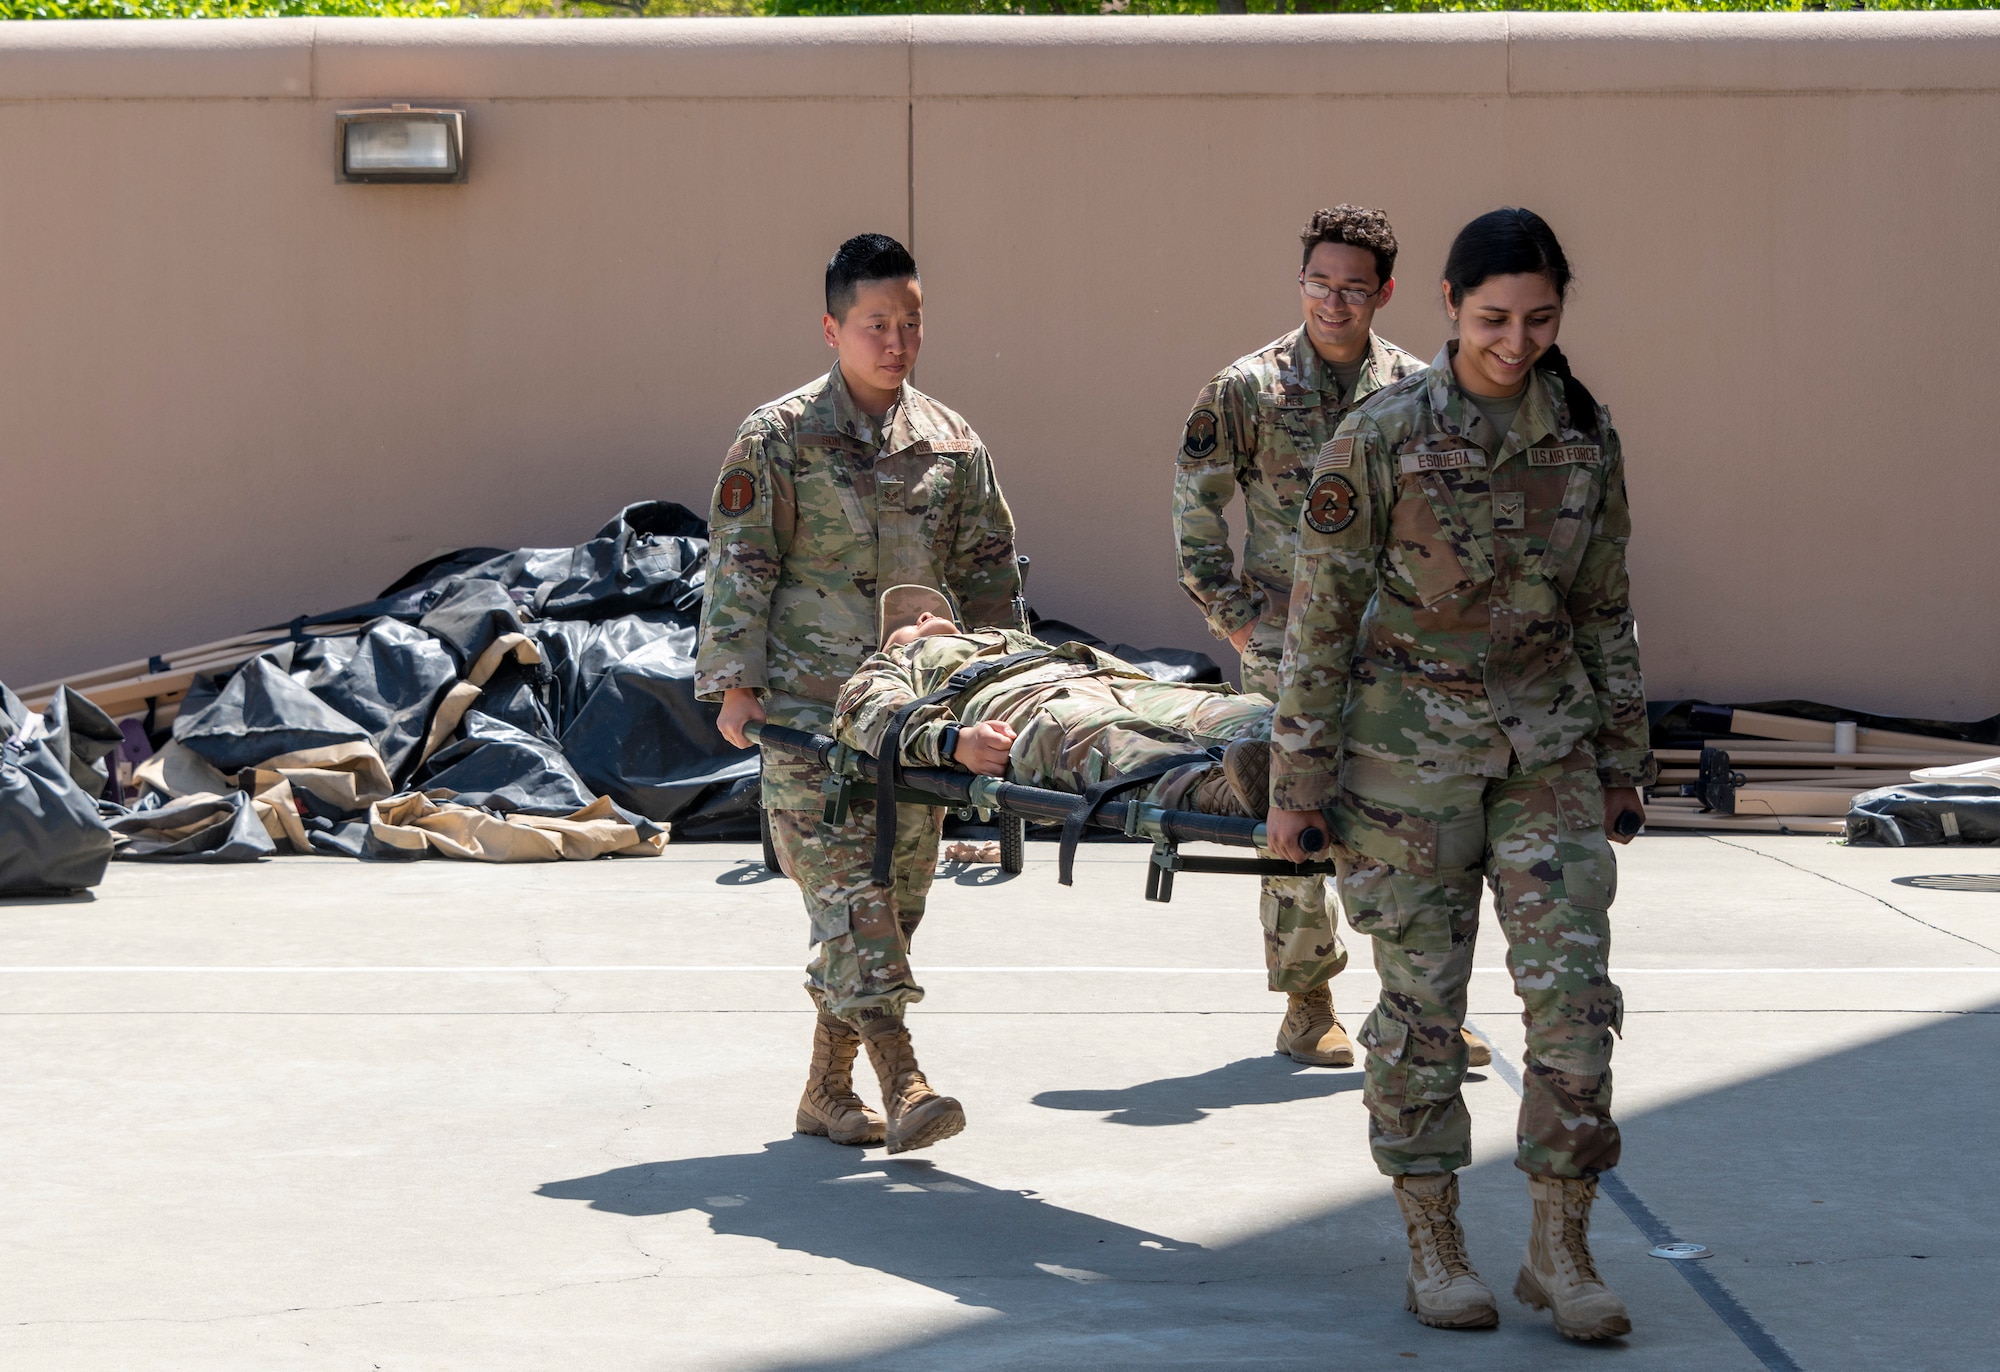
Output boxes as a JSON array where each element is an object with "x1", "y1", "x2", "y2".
[{"x1": 1332, "y1": 750, "x2": 1624, "y2": 1176}]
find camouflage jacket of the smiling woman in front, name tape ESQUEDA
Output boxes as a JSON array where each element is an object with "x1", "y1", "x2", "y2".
[{"x1": 1272, "y1": 344, "x2": 1656, "y2": 810}]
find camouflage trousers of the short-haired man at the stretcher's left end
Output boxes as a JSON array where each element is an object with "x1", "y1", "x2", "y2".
[{"x1": 770, "y1": 800, "x2": 944, "y2": 1022}]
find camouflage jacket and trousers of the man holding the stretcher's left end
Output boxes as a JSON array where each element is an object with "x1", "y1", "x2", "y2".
[{"x1": 694, "y1": 366, "x2": 1020, "y2": 1020}]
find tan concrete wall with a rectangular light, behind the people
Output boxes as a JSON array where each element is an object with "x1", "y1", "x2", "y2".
[{"x1": 0, "y1": 14, "x2": 2000, "y2": 716}]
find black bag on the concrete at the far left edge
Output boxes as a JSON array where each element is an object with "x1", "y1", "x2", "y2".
[{"x1": 0, "y1": 686, "x2": 112, "y2": 896}]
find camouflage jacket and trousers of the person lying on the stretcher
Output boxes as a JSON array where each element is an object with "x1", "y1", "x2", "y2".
[{"x1": 836, "y1": 630, "x2": 1272, "y2": 808}]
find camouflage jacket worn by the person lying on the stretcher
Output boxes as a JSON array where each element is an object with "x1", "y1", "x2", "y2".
[{"x1": 834, "y1": 628, "x2": 1152, "y2": 766}]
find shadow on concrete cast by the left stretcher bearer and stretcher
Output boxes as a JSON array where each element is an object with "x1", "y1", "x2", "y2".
[{"x1": 536, "y1": 1134, "x2": 1200, "y2": 1308}]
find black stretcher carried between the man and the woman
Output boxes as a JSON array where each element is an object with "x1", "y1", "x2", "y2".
[{"x1": 744, "y1": 722, "x2": 1334, "y2": 902}]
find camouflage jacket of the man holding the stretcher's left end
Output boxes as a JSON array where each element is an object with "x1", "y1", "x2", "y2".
[{"x1": 694, "y1": 364, "x2": 1020, "y2": 808}]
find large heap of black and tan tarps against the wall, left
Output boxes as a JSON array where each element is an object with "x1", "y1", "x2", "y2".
[{"x1": 11, "y1": 500, "x2": 1220, "y2": 862}]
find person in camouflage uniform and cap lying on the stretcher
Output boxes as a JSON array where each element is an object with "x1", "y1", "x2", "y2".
[{"x1": 834, "y1": 586, "x2": 1272, "y2": 820}]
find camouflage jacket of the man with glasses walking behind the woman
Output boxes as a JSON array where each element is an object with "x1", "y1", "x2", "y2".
[{"x1": 1174, "y1": 326, "x2": 1424, "y2": 638}]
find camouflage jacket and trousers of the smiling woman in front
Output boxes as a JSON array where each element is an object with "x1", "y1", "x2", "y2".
[{"x1": 1272, "y1": 348, "x2": 1656, "y2": 1178}]
